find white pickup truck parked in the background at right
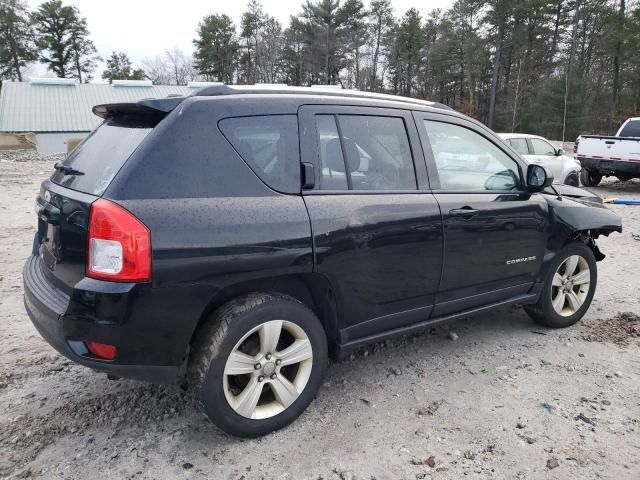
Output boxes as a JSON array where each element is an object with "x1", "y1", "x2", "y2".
[{"x1": 576, "y1": 117, "x2": 640, "y2": 187}]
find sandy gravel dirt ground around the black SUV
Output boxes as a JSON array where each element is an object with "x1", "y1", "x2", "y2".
[{"x1": 0, "y1": 152, "x2": 640, "y2": 480}]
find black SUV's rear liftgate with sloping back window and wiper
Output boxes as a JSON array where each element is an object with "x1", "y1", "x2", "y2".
[{"x1": 34, "y1": 116, "x2": 158, "y2": 292}]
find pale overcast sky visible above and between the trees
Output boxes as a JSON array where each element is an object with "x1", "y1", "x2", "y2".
[{"x1": 28, "y1": 0, "x2": 454, "y2": 79}]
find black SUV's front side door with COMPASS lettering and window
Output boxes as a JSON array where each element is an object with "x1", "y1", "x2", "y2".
[{"x1": 415, "y1": 112, "x2": 547, "y2": 316}]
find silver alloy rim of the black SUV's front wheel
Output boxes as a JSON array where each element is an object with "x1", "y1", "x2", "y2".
[{"x1": 551, "y1": 255, "x2": 591, "y2": 317}]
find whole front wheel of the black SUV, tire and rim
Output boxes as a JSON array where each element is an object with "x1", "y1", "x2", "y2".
[{"x1": 525, "y1": 242, "x2": 598, "y2": 328}]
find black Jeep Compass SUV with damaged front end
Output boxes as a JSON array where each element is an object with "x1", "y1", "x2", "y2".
[{"x1": 24, "y1": 85, "x2": 621, "y2": 437}]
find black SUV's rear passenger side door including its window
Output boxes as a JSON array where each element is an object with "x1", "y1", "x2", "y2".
[{"x1": 299, "y1": 106, "x2": 442, "y2": 344}]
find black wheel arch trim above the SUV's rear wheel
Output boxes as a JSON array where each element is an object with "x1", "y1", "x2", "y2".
[{"x1": 186, "y1": 273, "x2": 338, "y2": 358}]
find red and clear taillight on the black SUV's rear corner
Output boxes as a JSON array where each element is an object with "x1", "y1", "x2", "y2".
[{"x1": 87, "y1": 198, "x2": 151, "y2": 282}]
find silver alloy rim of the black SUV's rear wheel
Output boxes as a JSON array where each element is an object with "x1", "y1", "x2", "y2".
[{"x1": 223, "y1": 320, "x2": 313, "y2": 420}]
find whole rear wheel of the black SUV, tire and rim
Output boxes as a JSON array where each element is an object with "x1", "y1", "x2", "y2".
[{"x1": 191, "y1": 293, "x2": 328, "y2": 438}]
